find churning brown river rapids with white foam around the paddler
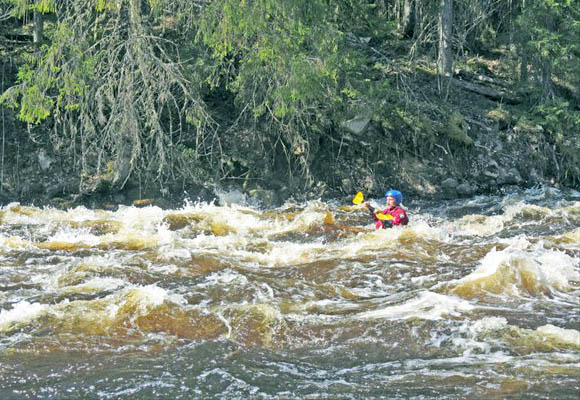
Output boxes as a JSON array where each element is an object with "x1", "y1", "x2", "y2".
[{"x1": 0, "y1": 187, "x2": 580, "y2": 400}]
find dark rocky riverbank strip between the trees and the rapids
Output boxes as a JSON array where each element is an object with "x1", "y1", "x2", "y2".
[{"x1": 0, "y1": 102, "x2": 560, "y2": 209}]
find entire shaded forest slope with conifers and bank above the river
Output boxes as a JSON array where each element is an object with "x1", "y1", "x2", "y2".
[{"x1": 0, "y1": 0, "x2": 580, "y2": 207}]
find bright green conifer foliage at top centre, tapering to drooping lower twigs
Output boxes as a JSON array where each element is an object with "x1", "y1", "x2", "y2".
[{"x1": 198, "y1": 0, "x2": 374, "y2": 181}]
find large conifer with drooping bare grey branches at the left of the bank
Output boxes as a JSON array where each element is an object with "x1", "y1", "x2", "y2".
[{"x1": 0, "y1": 0, "x2": 211, "y2": 190}]
